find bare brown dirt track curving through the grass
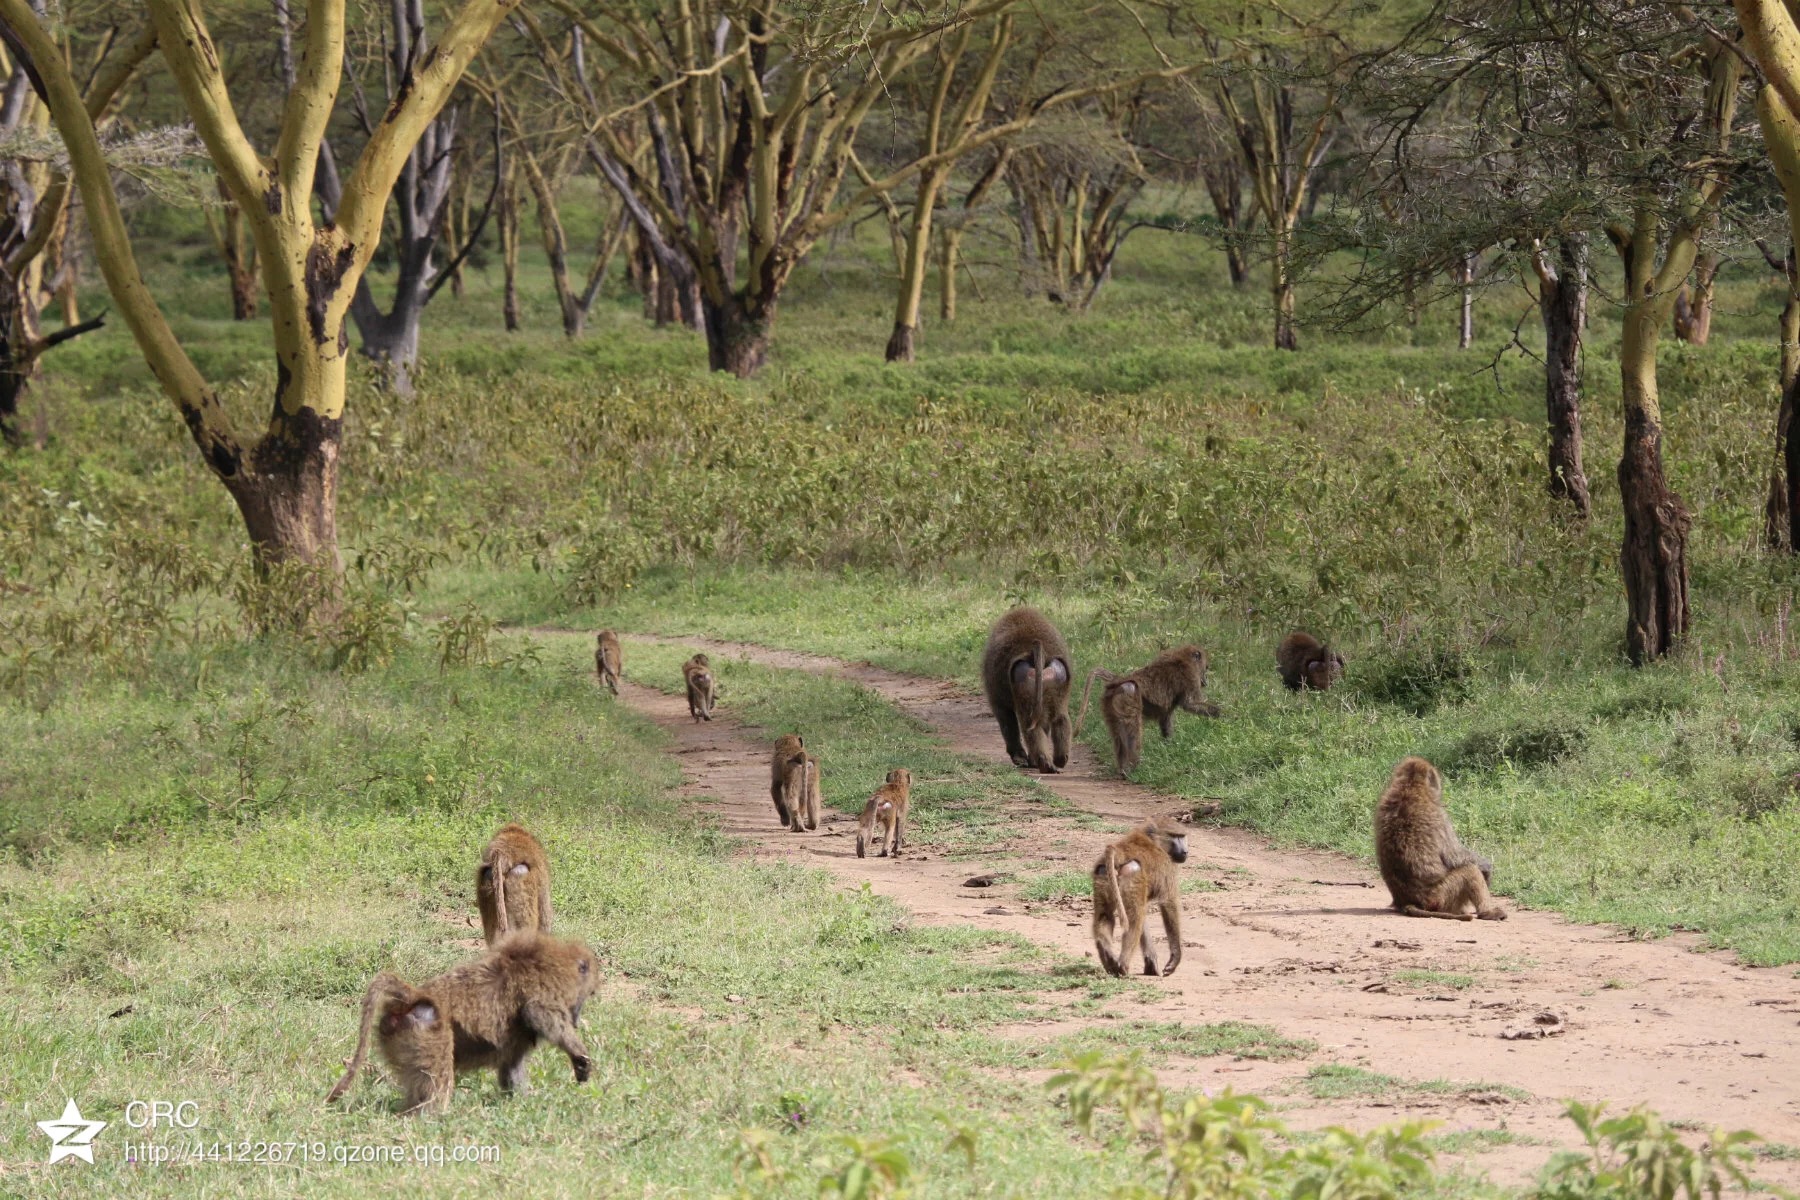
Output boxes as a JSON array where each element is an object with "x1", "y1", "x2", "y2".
[{"x1": 601, "y1": 637, "x2": 1800, "y2": 1187}]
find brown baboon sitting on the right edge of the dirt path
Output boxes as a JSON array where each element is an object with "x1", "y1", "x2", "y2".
[{"x1": 1375, "y1": 757, "x2": 1507, "y2": 921}]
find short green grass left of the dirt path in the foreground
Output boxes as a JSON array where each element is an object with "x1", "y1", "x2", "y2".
[{"x1": 0, "y1": 644, "x2": 1166, "y2": 1195}]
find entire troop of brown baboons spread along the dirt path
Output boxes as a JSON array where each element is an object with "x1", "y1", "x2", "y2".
[{"x1": 326, "y1": 608, "x2": 1507, "y2": 1112}]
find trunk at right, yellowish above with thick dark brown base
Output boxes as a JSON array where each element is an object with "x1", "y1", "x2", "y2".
[{"x1": 1618, "y1": 296, "x2": 1690, "y2": 666}]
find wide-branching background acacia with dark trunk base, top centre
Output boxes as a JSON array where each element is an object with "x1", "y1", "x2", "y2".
[{"x1": 547, "y1": 0, "x2": 1183, "y2": 376}]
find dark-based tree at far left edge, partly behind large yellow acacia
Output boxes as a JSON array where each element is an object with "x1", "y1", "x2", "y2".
[{"x1": 0, "y1": 14, "x2": 157, "y2": 444}]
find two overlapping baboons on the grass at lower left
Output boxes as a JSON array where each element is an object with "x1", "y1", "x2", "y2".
[{"x1": 326, "y1": 824, "x2": 599, "y2": 1114}]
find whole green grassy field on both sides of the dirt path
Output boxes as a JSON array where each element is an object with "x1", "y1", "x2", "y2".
[{"x1": 0, "y1": 188, "x2": 1800, "y2": 1196}]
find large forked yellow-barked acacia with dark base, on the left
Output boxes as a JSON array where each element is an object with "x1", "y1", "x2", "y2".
[{"x1": 0, "y1": 0, "x2": 518, "y2": 572}]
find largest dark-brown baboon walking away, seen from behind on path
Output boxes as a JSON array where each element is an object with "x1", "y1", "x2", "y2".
[{"x1": 981, "y1": 608, "x2": 1075, "y2": 774}]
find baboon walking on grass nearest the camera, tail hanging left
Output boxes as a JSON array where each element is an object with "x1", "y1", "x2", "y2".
[{"x1": 326, "y1": 934, "x2": 599, "y2": 1114}]
